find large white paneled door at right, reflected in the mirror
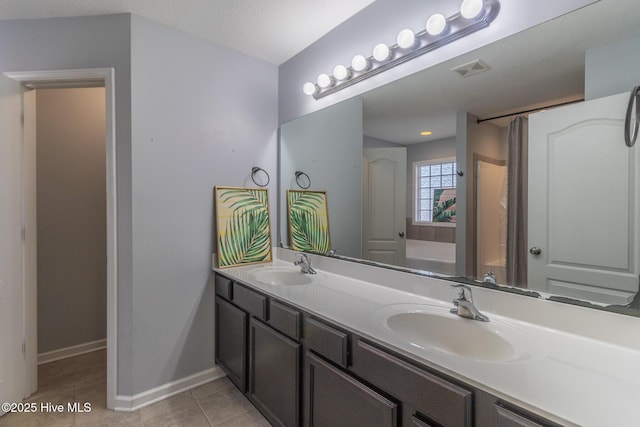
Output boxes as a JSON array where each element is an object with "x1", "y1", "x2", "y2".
[{"x1": 528, "y1": 94, "x2": 640, "y2": 304}]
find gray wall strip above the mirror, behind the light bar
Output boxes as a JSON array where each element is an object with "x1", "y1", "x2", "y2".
[{"x1": 278, "y1": 0, "x2": 594, "y2": 123}]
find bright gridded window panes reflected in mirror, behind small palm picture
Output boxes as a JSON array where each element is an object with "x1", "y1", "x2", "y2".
[{"x1": 413, "y1": 158, "x2": 456, "y2": 224}]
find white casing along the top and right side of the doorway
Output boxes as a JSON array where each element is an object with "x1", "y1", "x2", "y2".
[{"x1": 4, "y1": 68, "x2": 118, "y2": 408}]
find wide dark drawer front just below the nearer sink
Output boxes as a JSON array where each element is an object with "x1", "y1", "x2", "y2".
[{"x1": 351, "y1": 340, "x2": 473, "y2": 427}]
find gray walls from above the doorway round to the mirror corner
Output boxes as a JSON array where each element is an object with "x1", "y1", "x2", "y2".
[{"x1": 0, "y1": 15, "x2": 278, "y2": 396}]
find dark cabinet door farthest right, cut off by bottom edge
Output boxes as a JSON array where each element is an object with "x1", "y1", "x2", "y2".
[{"x1": 305, "y1": 352, "x2": 398, "y2": 427}]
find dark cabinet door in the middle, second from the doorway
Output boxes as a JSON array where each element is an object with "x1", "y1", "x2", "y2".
[{"x1": 249, "y1": 318, "x2": 301, "y2": 427}]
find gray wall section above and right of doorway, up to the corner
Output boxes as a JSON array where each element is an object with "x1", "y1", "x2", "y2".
[{"x1": 0, "y1": 14, "x2": 133, "y2": 395}]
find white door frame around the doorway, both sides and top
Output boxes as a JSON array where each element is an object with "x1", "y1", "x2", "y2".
[{"x1": 5, "y1": 68, "x2": 117, "y2": 408}]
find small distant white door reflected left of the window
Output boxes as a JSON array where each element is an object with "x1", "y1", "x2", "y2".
[{"x1": 362, "y1": 147, "x2": 407, "y2": 266}]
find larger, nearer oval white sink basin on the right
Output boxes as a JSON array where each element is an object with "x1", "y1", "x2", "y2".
[{"x1": 376, "y1": 304, "x2": 541, "y2": 362}]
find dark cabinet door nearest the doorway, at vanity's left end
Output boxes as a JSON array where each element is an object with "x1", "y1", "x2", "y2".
[{"x1": 215, "y1": 298, "x2": 248, "y2": 392}]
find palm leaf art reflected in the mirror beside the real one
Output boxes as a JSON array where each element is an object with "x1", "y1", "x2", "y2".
[{"x1": 287, "y1": 190, "x2": 331, "y2": 254}]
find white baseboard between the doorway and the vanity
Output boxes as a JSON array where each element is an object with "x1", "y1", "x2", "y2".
[{"x1": 113, "y1": 367, "x2": 226, "y2": 412}]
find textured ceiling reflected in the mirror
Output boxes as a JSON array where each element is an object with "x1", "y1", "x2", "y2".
[{"x1": 363, "y1": 0, "x2": 640, "y2": 144}]
